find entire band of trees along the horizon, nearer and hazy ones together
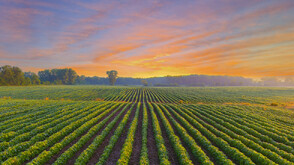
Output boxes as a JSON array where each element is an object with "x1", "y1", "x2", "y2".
[{"x1": 0, "y1": 65, "x2": 294, "y2": 86}]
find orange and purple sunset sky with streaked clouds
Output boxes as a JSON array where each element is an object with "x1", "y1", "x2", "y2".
[{"x1": 0, "y1": 0, "x2": 294, "y2": 78}]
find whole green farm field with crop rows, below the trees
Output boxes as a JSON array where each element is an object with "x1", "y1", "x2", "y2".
[{"x1": 0, "y1": 86, "x2": 294, "y2": 165}]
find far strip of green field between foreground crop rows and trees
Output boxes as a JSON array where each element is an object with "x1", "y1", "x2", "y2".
[{"x1": 0, "y1": 85, "x2": 294, "y2": 106}]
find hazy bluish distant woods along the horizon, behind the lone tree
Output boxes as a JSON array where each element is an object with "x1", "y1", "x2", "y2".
[{"x1": 76, "y1": 75, "x2": 294, "y2": 87}]
